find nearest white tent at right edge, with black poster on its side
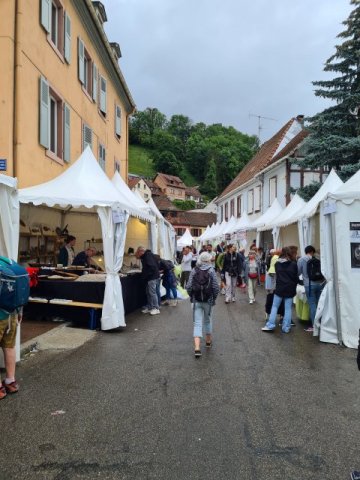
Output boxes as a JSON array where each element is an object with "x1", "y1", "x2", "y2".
[{"x1": 315, "y1": 170, "x2": 360, "y2": 348}]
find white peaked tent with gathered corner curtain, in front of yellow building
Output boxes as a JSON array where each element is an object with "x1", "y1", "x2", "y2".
[{"x1": 19, "y1": 147, "x2": 144, "y2": 330}]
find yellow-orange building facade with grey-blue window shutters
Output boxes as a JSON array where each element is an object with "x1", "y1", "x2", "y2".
[{"x1": 0, "y1": 0, "x2": 135, "y2": 188}]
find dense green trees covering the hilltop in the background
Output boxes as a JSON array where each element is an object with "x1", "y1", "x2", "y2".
[{"x1": 130, "y1": 108, "x2": 259, "y2": 197}]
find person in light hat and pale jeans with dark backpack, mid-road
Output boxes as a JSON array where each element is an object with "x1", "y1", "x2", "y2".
[{"x1": 186, "y1": 252, "x2": 219, "y2": 358}]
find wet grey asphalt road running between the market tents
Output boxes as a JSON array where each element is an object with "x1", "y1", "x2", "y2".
[{"x1": 0, "y1": 286, "x2": 360, "y2": 480}]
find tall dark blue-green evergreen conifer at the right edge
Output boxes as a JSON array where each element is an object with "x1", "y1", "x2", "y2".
[{"x1": 301, "y1": 0, "x2": 360, "y2": 180}]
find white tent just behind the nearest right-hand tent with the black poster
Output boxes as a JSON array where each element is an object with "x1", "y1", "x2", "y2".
[{"x1": 296, "y1": 170, "x2": 343, "y2": 252}]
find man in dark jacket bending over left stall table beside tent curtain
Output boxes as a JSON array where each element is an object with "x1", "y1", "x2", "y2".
[{"x1": 135, "y1": 247, "x2": 160, "y2": 315}]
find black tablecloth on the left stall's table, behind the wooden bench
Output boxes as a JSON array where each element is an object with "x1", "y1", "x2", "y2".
[{"x1": 30, "y1": 274, "x2": 147, "y2": 314}]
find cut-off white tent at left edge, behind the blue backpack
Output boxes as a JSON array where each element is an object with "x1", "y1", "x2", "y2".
[{"x1": 0, "y1": 174, "x2": 20, "y2": 366}]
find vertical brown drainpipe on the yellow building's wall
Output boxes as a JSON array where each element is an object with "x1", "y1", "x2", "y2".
[{"x1": 12, "y1": 0, "x2": 21, "y2": 177}]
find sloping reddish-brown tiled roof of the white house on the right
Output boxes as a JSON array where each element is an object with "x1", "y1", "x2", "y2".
[{"x1": 218, "y1": 118, "x2": 305, "y2": 200}]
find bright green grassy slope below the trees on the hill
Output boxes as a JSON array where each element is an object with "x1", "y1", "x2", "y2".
[{"x1": 129, "y1": 145, "x2": 197, "y2": 187}]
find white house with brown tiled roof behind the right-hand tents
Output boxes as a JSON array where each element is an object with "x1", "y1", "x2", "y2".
[{"x1": 215, "y1": 115, "x2": 328, "y2": 244}]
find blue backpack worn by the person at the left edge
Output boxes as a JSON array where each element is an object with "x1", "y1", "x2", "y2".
[{"x1": 0, "y1": 256, "x2": 30, "y2": 313}]
